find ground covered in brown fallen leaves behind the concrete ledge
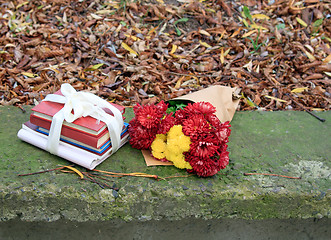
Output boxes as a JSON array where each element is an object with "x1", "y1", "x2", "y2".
[{"x1": 0, "y1": 0, "x2": 331, "y2": 110}]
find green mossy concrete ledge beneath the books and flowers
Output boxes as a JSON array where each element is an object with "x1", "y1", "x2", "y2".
[{"x1": 0, "y1": 107, "x2": 331, "y2": 222}]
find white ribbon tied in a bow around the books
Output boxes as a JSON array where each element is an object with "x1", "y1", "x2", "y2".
[{"x1": 44, "y1": 83, "x2": 124, "y2": 154}]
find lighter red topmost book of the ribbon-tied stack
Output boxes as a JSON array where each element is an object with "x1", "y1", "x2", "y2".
[{"x1": 31, "y1": 90, "x2": 125, "y2": 135}]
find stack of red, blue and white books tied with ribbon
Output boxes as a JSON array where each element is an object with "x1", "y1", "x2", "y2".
[{"x1": 17, "y1": 90, "x2": 129, "y2": 169}]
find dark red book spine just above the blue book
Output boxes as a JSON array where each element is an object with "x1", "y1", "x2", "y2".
[{"x1": 30, "y1": 114, "x2": 107, "y2": 148}]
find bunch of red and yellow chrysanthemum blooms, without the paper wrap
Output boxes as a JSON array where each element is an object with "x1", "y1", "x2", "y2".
[{"x1": 129, "y1": 101, "x2": 231, "y2": 177}]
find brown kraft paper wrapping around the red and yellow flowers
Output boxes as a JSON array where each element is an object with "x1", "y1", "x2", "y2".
[{"x1": 142, "y1": 85, "x2": 239, "y2": 166}]
